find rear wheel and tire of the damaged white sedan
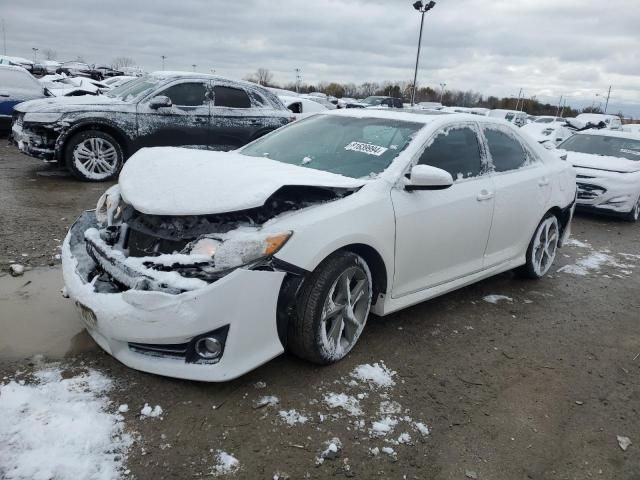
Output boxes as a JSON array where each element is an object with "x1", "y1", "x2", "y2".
[{"x1": 518, "y1": 213, "x2": 560, "y2": 279}]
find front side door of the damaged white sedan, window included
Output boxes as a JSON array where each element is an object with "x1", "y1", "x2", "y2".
[{"x1": 391, "y1": 123, "x2": 495, "y2": 298}]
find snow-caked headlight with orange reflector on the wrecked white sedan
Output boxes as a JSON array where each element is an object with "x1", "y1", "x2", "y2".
[{"x1": 185, "y1": 232, "x2": 293, "y2": 269}]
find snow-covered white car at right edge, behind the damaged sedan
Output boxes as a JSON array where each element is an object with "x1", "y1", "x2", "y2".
[{"x1": 558, "y1": 129, "x2": 640, "y2": 222}]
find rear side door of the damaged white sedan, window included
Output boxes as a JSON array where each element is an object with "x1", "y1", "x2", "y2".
[{"x1": 481, "y1": 124, "x2": 551, "y2": 267}]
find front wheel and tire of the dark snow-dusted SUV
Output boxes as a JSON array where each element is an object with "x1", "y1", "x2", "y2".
[{"x1": 65, "y1": 130, "x2": 124, "y2": 182}]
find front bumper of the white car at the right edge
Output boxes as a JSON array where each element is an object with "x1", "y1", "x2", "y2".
[{"x1": 575, "y1": 167, "x2": 640, "y2": 213}]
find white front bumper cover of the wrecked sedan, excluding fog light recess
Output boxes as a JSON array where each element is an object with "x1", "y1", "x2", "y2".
[{"x1": 62, "y1": 221, "x2": 285, "y2": 381}]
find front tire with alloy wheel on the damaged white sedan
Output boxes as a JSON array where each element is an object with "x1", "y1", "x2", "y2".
[{"x1": 288, "y1": 251, "x2": 372, "y2": 365}]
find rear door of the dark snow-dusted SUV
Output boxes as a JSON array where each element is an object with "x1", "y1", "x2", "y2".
[{"x1": 210, "y1": 82, "x2": 263, "y2": 150}]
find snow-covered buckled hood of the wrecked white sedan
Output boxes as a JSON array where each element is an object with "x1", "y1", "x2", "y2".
[{"x1": 119, "y1": 147, "x2": 367, "y2": 215}]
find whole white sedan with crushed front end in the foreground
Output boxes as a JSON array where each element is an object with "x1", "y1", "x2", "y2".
[{"x1": 63, "y1": 109, "x2": 576, "y2": 381}]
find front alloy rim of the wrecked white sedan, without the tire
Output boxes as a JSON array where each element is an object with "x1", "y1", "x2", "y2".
[{"x1": 320, "y1": 267, "x2": 371, "y2": 356}]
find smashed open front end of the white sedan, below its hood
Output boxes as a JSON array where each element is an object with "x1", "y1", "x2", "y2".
[{"x1": 70, "y1": 186, "x2": 351, "y2": 294}]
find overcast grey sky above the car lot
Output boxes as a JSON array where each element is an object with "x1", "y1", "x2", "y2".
[{"x1": 5, "y1": 0, "x2": 640, "y2": 117}]
